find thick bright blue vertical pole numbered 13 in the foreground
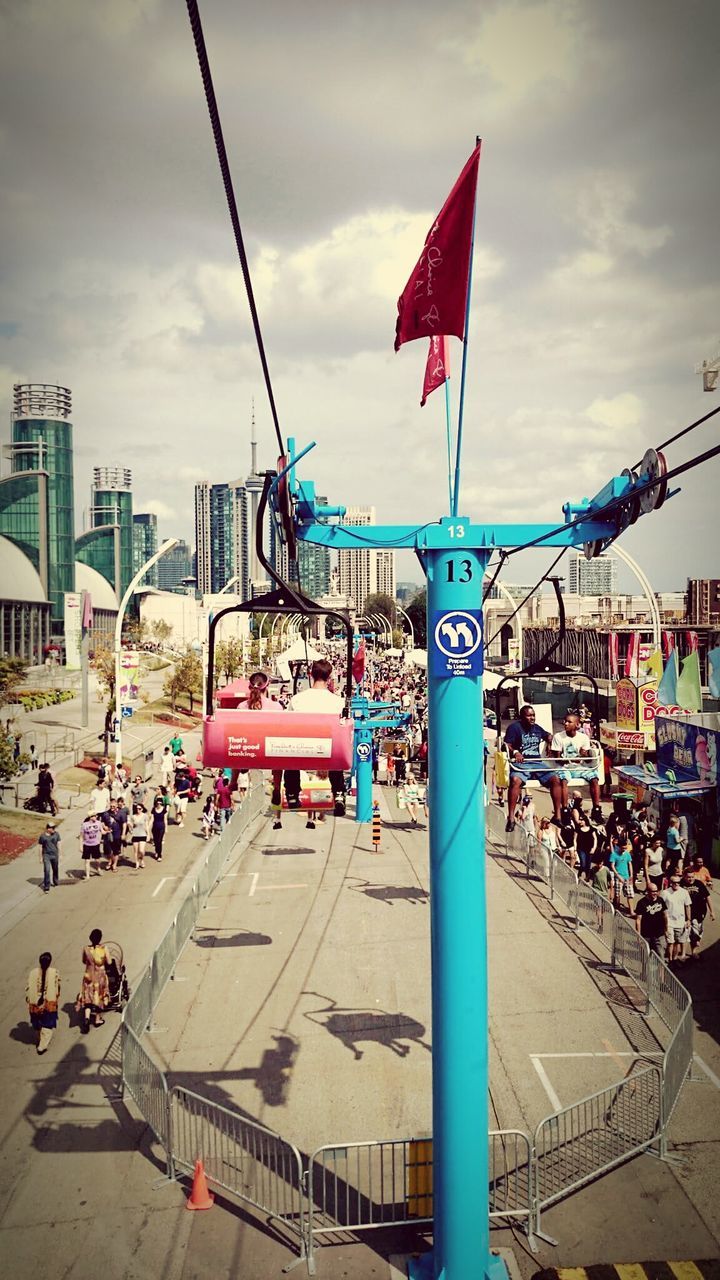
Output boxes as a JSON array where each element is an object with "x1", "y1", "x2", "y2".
[{"x1": 410, "y1": 535, "x2": 506, "y2": 1280}]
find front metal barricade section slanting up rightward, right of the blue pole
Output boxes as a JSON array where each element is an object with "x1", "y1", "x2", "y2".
[{"x1": 533, "y1": 1066, "x2": 662, "y2": 1231}]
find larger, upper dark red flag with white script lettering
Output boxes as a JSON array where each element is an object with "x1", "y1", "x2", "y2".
[{"x1": 395, "y1": 142, "x2": 480, "y2": 351}]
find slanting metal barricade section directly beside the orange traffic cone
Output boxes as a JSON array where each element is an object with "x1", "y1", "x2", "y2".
[{"x1": 170, "y1": 1085, "x2": 306, "y2": 1257}]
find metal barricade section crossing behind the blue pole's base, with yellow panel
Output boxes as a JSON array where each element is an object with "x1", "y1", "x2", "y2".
[{"x1": 307, "y1": 1129, "x2": 533, "y2": 1274}]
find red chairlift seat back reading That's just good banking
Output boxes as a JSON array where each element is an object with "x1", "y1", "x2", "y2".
[{"x1": 202, "y1": 708, "x2": 354, "y2": 771}]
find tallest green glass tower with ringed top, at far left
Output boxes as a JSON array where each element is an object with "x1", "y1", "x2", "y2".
[{"x1": 0, "y1": 383, "x2": 76, "y2": 626}]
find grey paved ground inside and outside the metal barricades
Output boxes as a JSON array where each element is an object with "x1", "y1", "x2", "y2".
[{"x1": 0, "y1": 691, "x2": 720, "y2": 1280}]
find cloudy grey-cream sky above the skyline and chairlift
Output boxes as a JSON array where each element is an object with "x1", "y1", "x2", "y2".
[{"x1": 0, "y1": 0, "x2": 720, "y2": 590}]
